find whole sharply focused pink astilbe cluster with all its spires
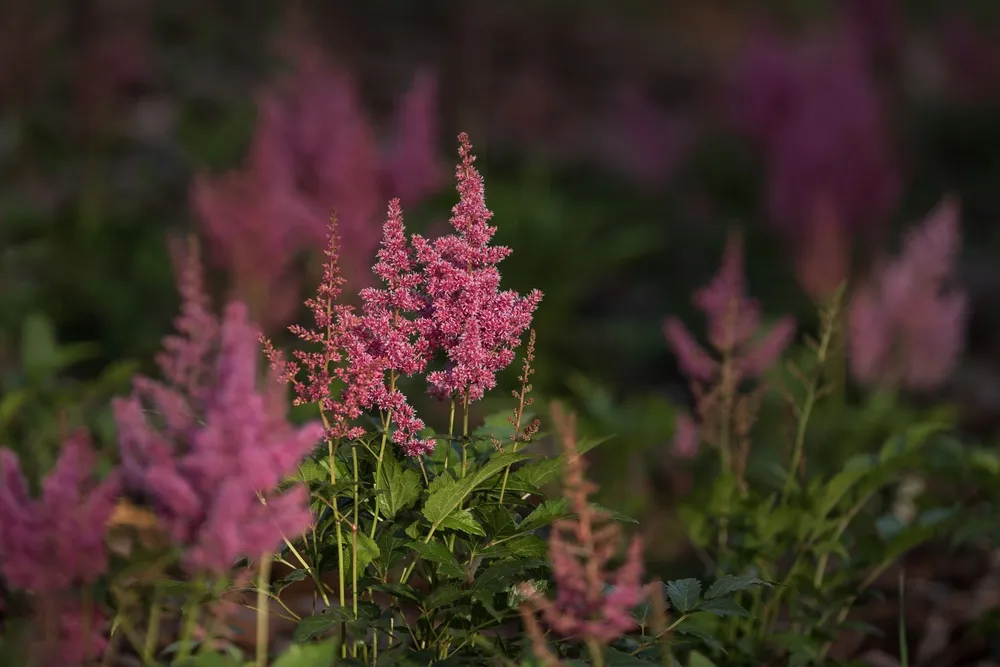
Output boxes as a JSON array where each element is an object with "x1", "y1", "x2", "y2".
[{"x1": 263, "y1": 134, "x2": 542, "y2": 456}]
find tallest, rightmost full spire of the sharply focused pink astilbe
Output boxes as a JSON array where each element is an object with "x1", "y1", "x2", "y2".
[{"x1": 413, "y1": 133, "x2": 542, "y2": 401}]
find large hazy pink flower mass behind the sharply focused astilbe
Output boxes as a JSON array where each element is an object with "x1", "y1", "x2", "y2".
[{"x1": 193, "y1": 28, "x2": 446, "y2": 330}]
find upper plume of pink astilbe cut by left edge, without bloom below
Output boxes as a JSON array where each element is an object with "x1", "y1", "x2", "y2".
[{"x1": 0, "y1": 432, "x2": 119, "y2": 595}]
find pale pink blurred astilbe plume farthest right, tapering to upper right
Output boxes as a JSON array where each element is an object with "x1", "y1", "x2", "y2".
[{"x1": 848, "y1": 199, "x2": 967, "y2": 390}]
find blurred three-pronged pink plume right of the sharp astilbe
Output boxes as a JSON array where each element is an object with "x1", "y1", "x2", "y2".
[{"x1": 664, "y1": 235, "x2": 795, "y2": 383}]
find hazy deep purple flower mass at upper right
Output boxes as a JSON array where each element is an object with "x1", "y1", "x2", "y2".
[{"x1": 733, "y1": 28, "x2": 900, "y2": 244}]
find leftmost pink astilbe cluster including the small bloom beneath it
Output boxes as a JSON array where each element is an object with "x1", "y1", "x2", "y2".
[{"x1": 0, "y1": 432, "x2": 119, "y2": 665}]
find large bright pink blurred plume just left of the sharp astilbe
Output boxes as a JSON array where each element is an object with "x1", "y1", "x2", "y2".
[{"x1": 113, "y1": 248, "x2": 323, "y2": 574}]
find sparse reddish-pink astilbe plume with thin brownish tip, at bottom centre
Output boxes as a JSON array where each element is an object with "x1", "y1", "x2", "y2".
[{"x1": 521, "y1": 404, "x2": 648, "y2": 644}]
